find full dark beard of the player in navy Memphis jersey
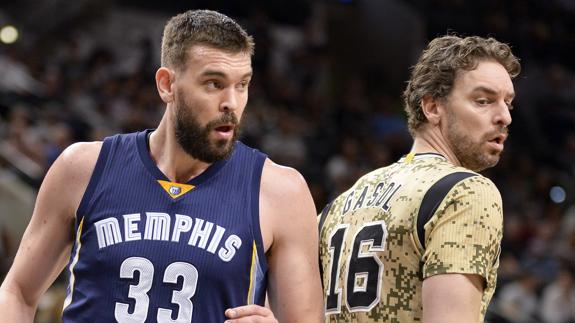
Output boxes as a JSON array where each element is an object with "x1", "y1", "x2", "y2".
[{"x1": 174, "y1": 92, "x2": 240, "y2": 163}]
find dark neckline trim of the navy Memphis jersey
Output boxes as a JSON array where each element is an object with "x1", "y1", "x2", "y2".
[{"x1": 136, "y1": 129, "x2": 232, "y2": 186}]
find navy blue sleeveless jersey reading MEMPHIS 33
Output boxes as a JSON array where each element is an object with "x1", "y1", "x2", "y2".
[{"x1": 63, "y1": 131, "x2": 267, "y2": 323}]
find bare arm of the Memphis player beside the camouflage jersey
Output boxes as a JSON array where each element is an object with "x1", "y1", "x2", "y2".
[{"x1": 226, "y1": 160, "x2": 323, "y2": 323}]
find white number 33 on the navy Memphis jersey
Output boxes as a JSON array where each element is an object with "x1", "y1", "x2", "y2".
[{"x1": 114, "y1": 257, "x2": 198, "y2": 323}]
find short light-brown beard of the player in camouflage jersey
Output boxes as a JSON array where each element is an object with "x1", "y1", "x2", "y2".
[{"x1": 447, "y1": 110, "x2": 507, "y2": 172}]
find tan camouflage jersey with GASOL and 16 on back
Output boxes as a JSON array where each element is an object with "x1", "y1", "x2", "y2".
[{"x1": 319, "y1": 153, "x2": 503, "y2": 322}]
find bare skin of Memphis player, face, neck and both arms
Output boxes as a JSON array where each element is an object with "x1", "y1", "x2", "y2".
[{"x1": 0, "y1": 45, "x2": 323, "y2": 323}]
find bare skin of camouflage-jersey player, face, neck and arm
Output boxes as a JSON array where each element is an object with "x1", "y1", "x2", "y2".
[{"x1": 412, "y1": 60, "x2": 515, "y2": 323}]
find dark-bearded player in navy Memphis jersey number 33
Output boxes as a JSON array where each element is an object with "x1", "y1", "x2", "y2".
[{"x1": 0, "y1": 10, "x2": 323, "y2": 323}]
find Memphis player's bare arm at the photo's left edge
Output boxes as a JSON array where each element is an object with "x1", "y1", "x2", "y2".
[{"x1": 0, "y1": 143, "x2": 101, "y2": 323}]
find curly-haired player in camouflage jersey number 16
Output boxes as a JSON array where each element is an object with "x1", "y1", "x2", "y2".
[{"x1": 319, "y1": 36, "x2": 520, "y2": 323}]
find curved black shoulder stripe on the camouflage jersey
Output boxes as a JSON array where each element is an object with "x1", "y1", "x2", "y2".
[{"x1": 414, "y1": 172, "x2": 477, "y2": 251}]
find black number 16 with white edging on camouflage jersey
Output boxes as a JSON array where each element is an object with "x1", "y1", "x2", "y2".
[{"x1": 326, "y1": 221, "x2": 387, "y2": 313}]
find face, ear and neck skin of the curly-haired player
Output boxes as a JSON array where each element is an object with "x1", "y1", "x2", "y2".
[{"x1": 412, "y1": 61, "x2": 515, "y2": 171}]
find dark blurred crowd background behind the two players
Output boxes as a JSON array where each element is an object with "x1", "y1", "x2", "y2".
[{"x1": 0, "y1": 0, "x2": 575, "y2": 323}]
